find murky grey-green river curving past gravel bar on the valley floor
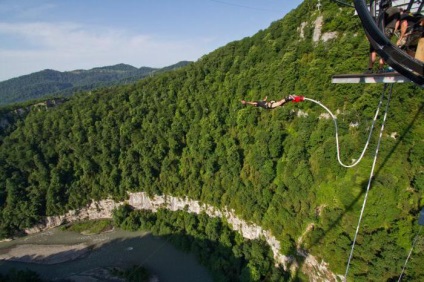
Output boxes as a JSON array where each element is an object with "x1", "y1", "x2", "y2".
[{"x1": 0, "y1": 228, "x2": 212, "y2": 282}]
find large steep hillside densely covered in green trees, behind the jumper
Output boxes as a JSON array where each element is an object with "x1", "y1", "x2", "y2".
[{"x1": 0, "y1": 0, "x2": 424, "y2": 281}]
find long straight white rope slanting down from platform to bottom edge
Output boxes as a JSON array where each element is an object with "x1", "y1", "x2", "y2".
[{"x1": 344, "y1": 84, "x2": 393, "y2": 281}]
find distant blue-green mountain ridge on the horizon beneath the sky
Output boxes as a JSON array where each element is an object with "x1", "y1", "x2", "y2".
[{"x1": 0, "y1": 61, "x2": 191, "y2": 106}]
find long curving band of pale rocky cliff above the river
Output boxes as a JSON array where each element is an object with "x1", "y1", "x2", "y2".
[{"x1": 25, "y1": 192, "x2": 342, "y2": 281}]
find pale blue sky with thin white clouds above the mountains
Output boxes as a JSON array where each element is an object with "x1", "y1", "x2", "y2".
[{"x1": 0, "y1": 0, "x2": 302, "y2": 81}]
